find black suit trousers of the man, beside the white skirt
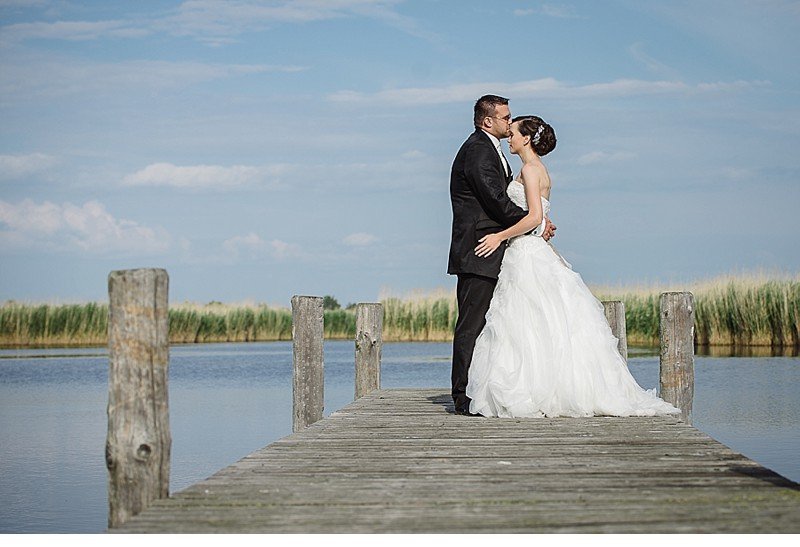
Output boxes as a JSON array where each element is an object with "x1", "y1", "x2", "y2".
[{"x1": 451, "y1": 274, "x2": 497, "y2": 410}]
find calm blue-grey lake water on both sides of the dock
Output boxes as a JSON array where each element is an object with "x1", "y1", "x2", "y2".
[{"x1": 0, "y1": 341, "x2": 800, "y2": 533}]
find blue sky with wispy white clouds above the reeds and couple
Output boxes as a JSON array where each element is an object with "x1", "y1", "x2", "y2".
[{"x1": 0, "y1": 0, "x2": 800, "y2": 305}]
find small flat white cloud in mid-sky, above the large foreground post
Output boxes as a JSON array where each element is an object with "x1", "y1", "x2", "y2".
[{"x1": 122, "y1": 163, "x2": 289, "y2": 190}]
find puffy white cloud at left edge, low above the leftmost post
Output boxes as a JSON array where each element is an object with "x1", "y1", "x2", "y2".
[{"x1": 0, "y1": 199, "x2": 170, "y2": 255}]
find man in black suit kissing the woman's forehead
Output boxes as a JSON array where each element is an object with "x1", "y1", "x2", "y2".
[{"x1": 447, "y1": 95, "x2": 556, "y2": 415}]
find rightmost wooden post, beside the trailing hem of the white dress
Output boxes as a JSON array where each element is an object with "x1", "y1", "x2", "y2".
[{"x1": 659, "y1": 292, "x2": 694, "y2": 424}]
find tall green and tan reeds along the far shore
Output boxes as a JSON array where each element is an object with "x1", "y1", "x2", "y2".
[{"x1": 0, "y1": 276, "x2": 800, "y2": 347}]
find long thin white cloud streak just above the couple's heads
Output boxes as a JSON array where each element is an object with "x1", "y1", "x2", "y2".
[{"x1": 328, "y1": 78, "x2": 769, "y2": 105}]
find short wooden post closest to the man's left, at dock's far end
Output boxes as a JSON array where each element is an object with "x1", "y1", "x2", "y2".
[{"x1": 356, "y1": 304, "x2": 383, "y2": 399}]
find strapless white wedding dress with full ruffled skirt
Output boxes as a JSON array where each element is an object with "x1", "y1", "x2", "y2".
[{"x1": 467, "y1": 180, "x2": 680, "y2": 417}]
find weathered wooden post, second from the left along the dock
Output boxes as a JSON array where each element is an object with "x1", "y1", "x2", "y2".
[{"x1": 292, "y1": 296, "x2": 325, "y2": 432}]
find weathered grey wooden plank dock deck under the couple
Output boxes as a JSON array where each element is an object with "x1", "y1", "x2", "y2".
[{"x1": 112, "y1": 389, "x2": 800, "y2": 533}]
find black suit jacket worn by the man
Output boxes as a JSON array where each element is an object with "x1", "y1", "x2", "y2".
[{"x1": 447, "y1": 129, "x2": 527, "y2": 278}]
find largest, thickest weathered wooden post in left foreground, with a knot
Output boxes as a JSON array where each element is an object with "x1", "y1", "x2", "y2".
[{"x1": 106, "y1": 269, "x2": 172, "y2": 528}]
